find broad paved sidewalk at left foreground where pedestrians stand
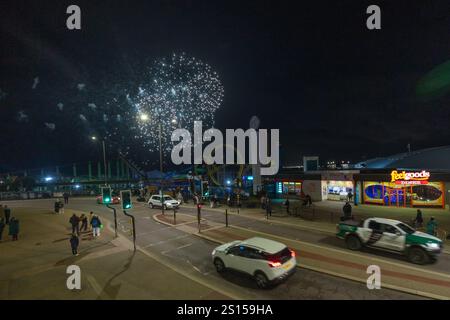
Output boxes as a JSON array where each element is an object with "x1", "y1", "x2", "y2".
[{"x1": 0, "y1": 208, "x2": 228, "y2": 300}]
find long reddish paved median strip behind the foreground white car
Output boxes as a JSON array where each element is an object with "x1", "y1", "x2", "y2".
[{"x1": 153, "y1": 214, "x2": 450, "y2": 300}]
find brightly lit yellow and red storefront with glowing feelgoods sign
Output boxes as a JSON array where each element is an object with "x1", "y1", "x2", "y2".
[{"x1": 361, "y1": 170, "x2": 445, "y2": 208}]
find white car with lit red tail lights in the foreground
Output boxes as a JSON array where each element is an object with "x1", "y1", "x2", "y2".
[{"x1": 212, "y1": 237, "x2": 297, "y2": 288}]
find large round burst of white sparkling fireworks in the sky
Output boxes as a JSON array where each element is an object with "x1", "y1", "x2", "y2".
[{"x1": 134, "y1": 53, "x2": 224, "y2": 153}]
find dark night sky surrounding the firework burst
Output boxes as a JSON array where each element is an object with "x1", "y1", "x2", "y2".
[{"x1": 0, "y1": 0, "x2": 450, "y2": 172}]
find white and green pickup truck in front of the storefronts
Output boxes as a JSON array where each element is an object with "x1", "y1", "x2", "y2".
[{"x1": 336, "y1": 218, "x2": 443, "y2": 264}]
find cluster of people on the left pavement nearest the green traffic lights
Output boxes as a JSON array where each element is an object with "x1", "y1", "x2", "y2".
[{"x1": 69, "y1": 211, "x2": 103, "y2": 256}]
